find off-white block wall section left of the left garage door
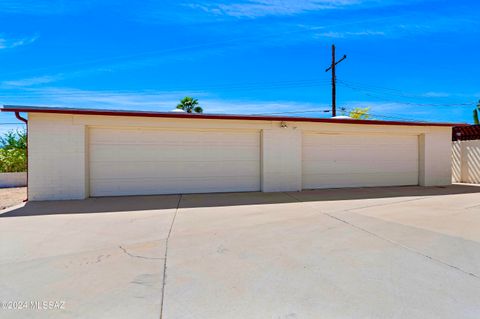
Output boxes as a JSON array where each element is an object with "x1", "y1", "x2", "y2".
[{"x1": 28, "y1": 113, "x2": 88, "y2": 201}]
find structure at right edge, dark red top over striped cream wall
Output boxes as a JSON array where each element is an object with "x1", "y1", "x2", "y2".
[{"x1": 452, "y1": 125, "x2": 480, "y2": 184}]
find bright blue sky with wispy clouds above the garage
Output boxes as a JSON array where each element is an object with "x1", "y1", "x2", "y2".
[{"x1": 0, "y1": 0, "x2": 480, "y2": 133}]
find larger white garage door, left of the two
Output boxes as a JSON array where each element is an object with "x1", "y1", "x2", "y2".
[{"x1": 89, "y1": 128, "x2": 260, "y2": 196}]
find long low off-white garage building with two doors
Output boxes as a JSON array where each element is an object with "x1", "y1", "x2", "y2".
[{"x1": 2, "y1": 106, "x2": 464, "y2": 200}]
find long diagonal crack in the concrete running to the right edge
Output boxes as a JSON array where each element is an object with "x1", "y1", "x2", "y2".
[{"x1": 285, "y1": 193, "x2": 480, "y2": 279}]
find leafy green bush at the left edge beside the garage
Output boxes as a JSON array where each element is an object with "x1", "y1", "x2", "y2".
[{"x1": 0, "y1": 131, "x2": 27, "y2": 173}]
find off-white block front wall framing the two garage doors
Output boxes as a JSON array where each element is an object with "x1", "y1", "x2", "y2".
[{"x1": 29, "y1": 113, "x2": 451, "y2": 200}]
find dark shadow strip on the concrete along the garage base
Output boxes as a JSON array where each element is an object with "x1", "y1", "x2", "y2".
[{"x1": 0, "y1": 184, "x2": 480, "y2": 218}]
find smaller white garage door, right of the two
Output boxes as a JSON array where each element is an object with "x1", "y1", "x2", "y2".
[{"x1": 302, "y1": 133, "x2": 418, "y2": 189}]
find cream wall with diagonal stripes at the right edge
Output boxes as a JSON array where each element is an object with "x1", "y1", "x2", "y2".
[{"x1": 452, "y1": 140, "x2": 480, "y2": 184}]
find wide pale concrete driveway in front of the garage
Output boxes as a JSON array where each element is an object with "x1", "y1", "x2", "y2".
[{"x1": 0, "y1": 185, "x2": 480, "y2": 319}]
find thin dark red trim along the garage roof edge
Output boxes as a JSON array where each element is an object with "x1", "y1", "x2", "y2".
[{"x1": 0, "y1": 105, "x2": 467, "y2": 126}]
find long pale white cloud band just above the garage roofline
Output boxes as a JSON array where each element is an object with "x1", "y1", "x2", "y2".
[{"x1": 0, "y1": 87, "x2": 464, "y2": 121}]
